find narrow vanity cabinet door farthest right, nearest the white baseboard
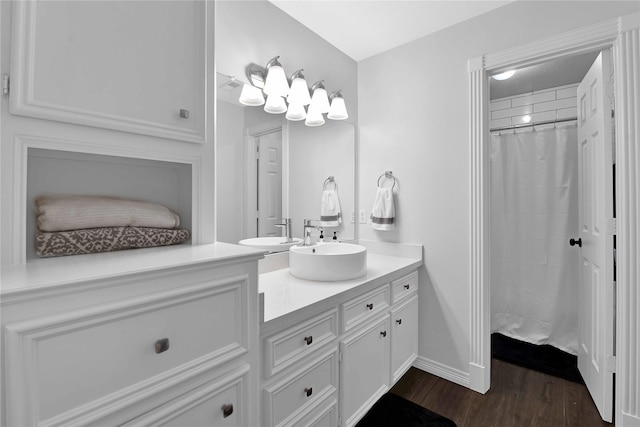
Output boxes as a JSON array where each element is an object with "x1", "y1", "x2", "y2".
[{"x1": 391, "y1": 296, "x2": 418, "y2": 384}]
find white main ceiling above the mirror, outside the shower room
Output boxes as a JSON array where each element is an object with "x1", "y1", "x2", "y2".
[{"x1": 269, "y1": 0, "x2": 513, "y2": 61}]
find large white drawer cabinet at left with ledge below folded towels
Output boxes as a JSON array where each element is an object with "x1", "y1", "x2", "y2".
[{"x1": 2, "y1": 244, "x2": 262, "y2": 426}]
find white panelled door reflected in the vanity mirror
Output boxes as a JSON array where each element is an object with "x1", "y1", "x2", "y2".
[{"x1": 257, "y1": 130, "x2": 282, "y2": 237}]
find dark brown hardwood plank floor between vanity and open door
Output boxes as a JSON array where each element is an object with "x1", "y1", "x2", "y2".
[{"x1": 391, "y1": 359, "x2": 613, "y2": 427}]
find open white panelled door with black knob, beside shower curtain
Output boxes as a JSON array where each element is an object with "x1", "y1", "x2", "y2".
[{"x1": 571, "y1": 52, "x2": 615, "y2": 422}]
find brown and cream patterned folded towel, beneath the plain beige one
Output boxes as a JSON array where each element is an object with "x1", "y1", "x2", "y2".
[{"x1": 36, "y1": 227, "x2": 189, "y2": 257}]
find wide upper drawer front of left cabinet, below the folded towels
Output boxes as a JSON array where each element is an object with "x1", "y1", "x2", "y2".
[{"x1": 6, "y1": 277, "x2": 248, "y2": 425}]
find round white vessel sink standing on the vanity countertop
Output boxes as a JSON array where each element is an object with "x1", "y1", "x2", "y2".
[{"x1": 289, "y1": 243, "x2": 367, "y2": 282}]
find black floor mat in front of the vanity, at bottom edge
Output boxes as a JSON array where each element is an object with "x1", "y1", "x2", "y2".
[{"x1": 356, "y1": 393, "x2": 456, "y2": 427}]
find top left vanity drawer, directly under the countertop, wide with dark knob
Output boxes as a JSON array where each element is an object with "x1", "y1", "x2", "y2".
[{"x1": 264, "y1": 310, "x2": 338, "y2": 378}]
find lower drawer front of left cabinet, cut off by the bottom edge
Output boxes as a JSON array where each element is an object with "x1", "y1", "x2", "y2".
[{"x1": 123, "y1": 365, "x2": 249, "y2": 427}]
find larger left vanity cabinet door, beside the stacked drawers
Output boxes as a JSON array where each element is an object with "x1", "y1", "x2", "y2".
[{"x1": 340, "y1": 315, "x2": 391, "y2": 426}]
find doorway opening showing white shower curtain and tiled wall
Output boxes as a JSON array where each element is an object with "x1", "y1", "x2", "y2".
[{"x1": 487, "y1": 50, "x2": 614, "y2": 394}]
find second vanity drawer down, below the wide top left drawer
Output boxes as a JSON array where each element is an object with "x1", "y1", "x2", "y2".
[{"x1": 264, "y1": 348, "x2": 338, "y2": 427}]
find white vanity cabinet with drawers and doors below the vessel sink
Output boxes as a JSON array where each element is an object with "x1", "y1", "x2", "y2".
[{"x1": 261, "y1": 269, "x2": 418, "y2": 427}]
